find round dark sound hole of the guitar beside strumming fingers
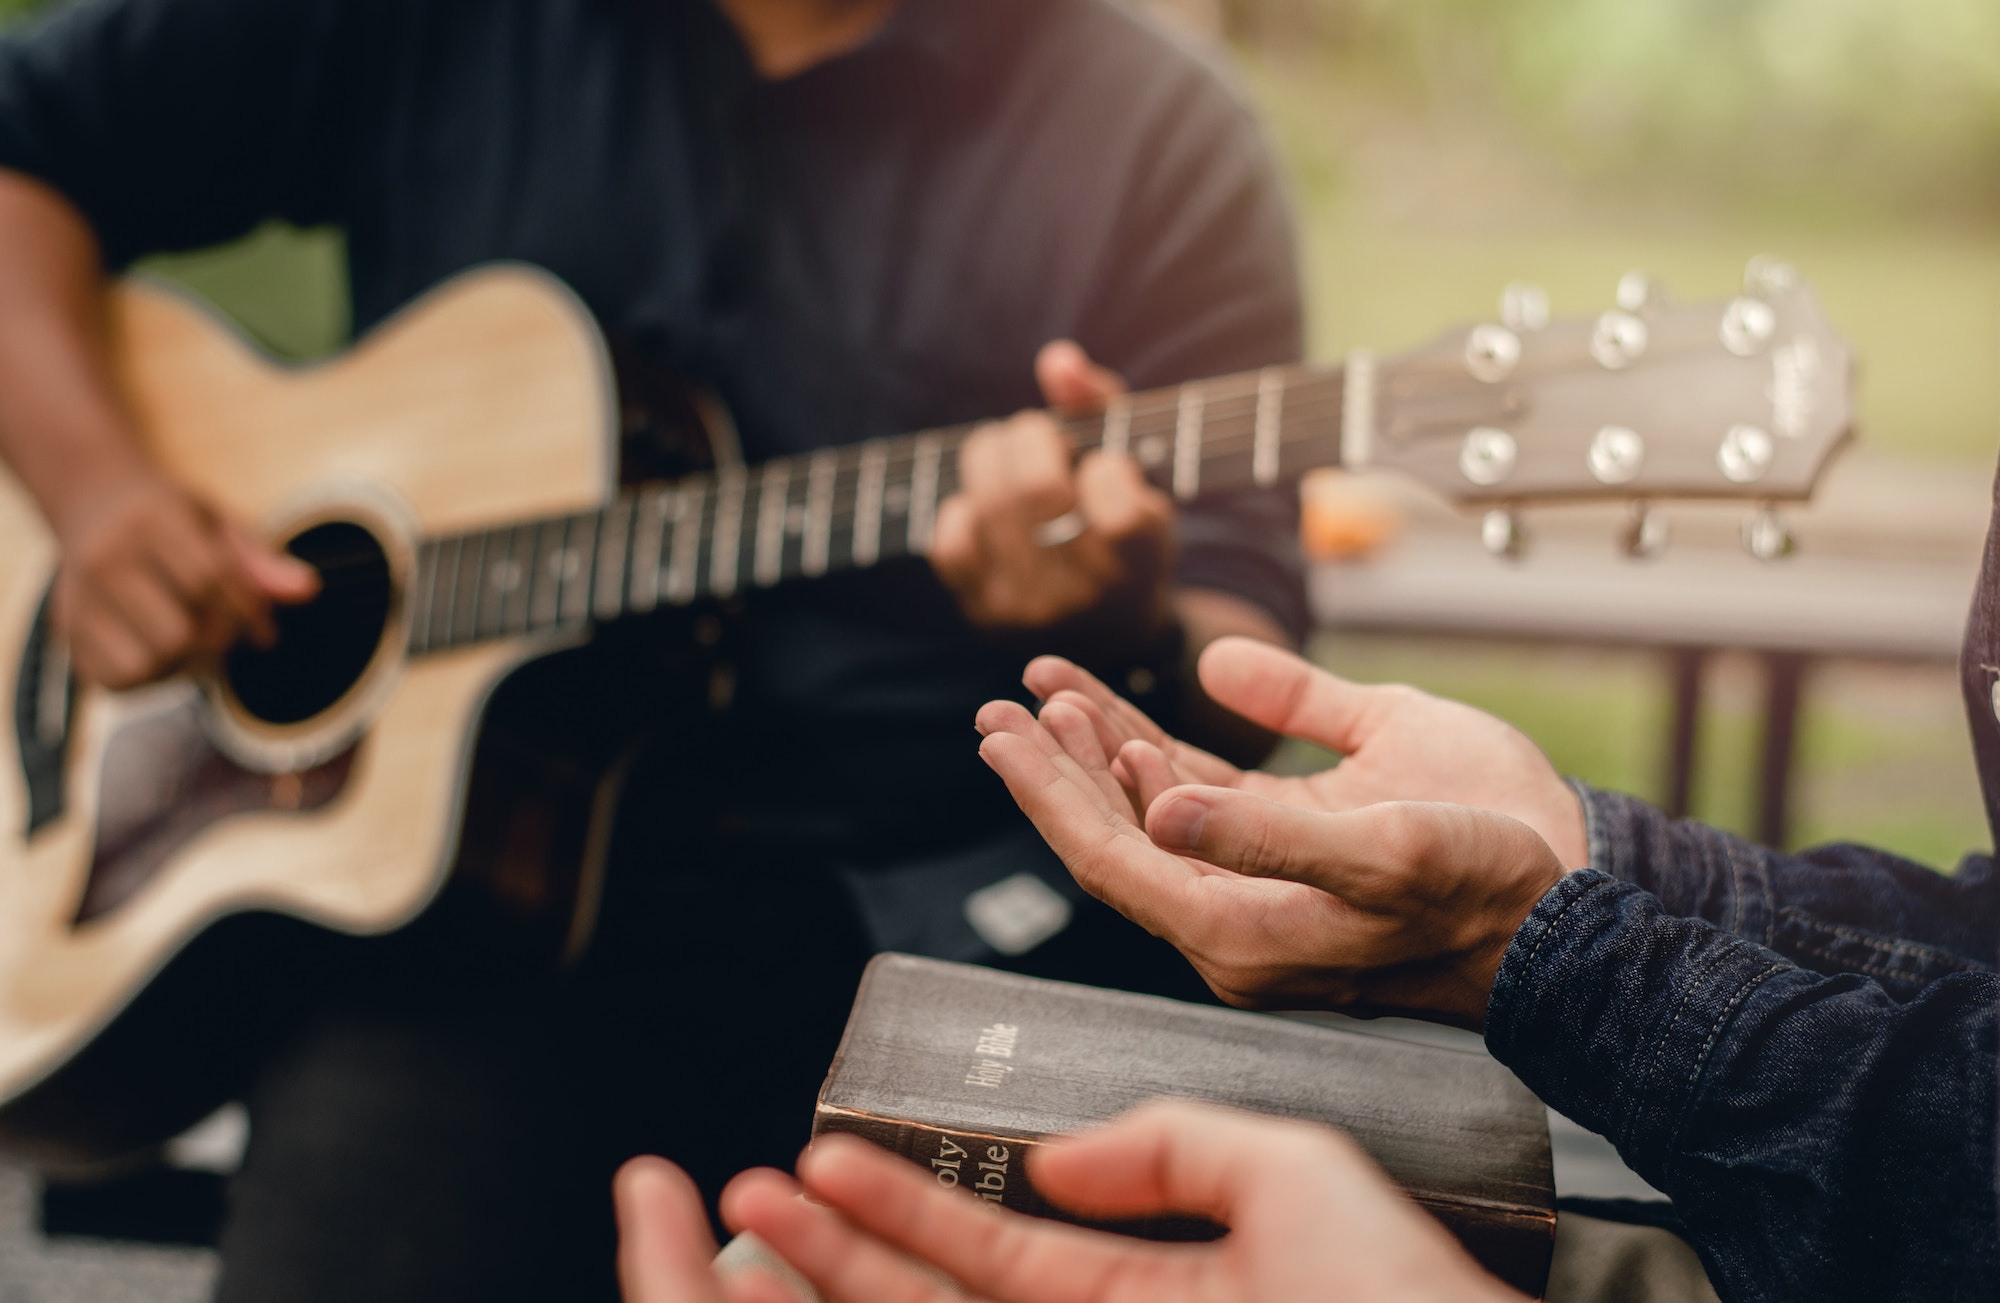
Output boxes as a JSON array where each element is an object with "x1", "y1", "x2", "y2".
[{"x1": 224, "y1": 522, "x2": 390, "y2": 723}]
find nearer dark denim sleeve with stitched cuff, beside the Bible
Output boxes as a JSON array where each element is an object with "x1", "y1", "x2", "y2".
[{"x1": 1486, "y1": 875, "x2": 2000, "y2": 1301}]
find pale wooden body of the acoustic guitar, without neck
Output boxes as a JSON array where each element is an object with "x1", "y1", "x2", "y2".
[{"x1": 0, "y1": 268, "x2": 618, "y2": 1161}]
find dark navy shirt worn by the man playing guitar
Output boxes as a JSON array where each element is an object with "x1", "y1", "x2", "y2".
[{"x1": 0, "y1": 0, "x2": 1306, "y2": 871}]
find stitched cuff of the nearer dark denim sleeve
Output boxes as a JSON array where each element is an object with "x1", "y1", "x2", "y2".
[{"x1": 1486, "y1": 869, "x2": 1786, "y2": 1185}]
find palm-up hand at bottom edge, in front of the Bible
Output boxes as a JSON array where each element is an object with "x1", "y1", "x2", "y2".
[{"x1": 716, "y1": 1103, "x2": 1518, "y2": 1303}]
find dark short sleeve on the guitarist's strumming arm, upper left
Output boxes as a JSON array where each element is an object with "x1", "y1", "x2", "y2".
[{"x1": 0, "y1": 0, "x2": 364, "y2": 268}]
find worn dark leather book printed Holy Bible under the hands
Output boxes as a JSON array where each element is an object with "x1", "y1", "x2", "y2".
[{"x1": 812, "y1": 955, "x2": 1556, "y2": 1297}]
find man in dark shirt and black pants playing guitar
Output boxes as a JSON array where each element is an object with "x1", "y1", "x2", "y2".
[{"x1": 0, "y1": 0, "x2": 1304, "y2": 1299}]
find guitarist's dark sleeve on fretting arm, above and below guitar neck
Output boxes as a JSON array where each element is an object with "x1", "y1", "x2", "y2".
[{"x1": 1080, "y1": 43, "x2": 1308, "y2": 640}]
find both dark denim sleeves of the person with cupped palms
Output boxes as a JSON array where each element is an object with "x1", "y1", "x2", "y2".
[{"x1": 1486, "y1": 791, "x2": 2000, "y2": 1303}]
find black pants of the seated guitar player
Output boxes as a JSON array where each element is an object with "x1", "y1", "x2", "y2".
[{"x1": 207, "y1": 747, "x2": 1204, "y2": 1303}]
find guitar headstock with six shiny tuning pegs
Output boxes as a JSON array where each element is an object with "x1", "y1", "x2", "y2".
[{"x1": 1368, "y1": 258, "x2": 1852, "y2": 558}]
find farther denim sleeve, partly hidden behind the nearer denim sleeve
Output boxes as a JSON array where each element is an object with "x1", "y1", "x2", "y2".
[{"x1": 1576, "y1": 783, "x2": 2000, "y2": 997}]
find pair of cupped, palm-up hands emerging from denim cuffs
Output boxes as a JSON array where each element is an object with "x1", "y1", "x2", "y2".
[{"x1": 978, "y1": 640, "x2": 1582, "y2": 1029}]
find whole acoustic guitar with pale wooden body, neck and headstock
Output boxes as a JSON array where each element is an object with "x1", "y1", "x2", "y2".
[{"x1": 0, "y1": 262, "x2": 1850, "y2": 1161}]
